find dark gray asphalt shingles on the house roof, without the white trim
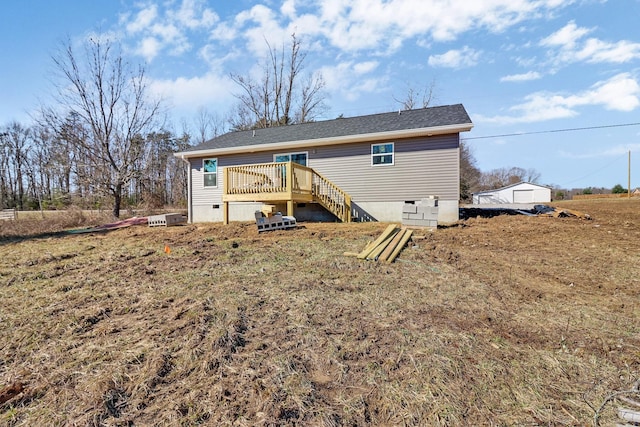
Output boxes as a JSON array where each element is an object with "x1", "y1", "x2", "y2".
[{"x1": 186, "y1": 104, "x2": 471, "y2": 152}]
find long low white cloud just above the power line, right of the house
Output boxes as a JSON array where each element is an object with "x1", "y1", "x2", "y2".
[{"x1": 479, "y1": 73, "x2": 640, "y2": 124}]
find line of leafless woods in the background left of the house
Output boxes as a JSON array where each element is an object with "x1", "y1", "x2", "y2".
[{"x1": 0, "y1": 117, "x2": 192, "y2": 215}]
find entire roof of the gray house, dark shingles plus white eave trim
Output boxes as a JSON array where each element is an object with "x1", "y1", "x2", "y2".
[{"x1": 176, "y1": 104, "x2": 473, "y2": 157}]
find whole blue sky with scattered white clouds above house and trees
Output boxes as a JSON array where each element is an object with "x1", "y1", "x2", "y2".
[{"x1": 0, "y1": 0, "x2": 640, "y2": 189}]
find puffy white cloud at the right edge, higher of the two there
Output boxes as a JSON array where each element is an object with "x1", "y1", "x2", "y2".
[{"x1": 540, "y1": 21, "x2": 640, "y2": 64}]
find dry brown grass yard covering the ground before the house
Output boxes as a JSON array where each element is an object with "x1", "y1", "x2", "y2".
[{"x1": 0, "y1": 199, "x2": 640, "y2": 427}]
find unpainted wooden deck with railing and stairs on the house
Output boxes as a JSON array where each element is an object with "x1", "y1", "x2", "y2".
[{"x1": 222, "y1": 162, "x2": 351, "y2": 224}]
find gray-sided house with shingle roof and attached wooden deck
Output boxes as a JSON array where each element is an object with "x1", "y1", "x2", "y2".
[{"x1": 175, "y1": 104, "x2": 473, "y2": 223}]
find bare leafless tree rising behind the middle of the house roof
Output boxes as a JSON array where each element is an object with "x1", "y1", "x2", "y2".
[{"x1": 230, "y1": 34, "x2": 326, "y2": 130}]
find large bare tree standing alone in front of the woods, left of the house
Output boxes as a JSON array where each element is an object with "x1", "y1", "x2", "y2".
[{"x1": 43, "y1": 38, "x2": 161, "y2": 217}]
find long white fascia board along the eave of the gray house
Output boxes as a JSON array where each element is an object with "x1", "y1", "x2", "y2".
[{"x1": 174, "y1": 123, "x2": 473, "y2": 159}]
